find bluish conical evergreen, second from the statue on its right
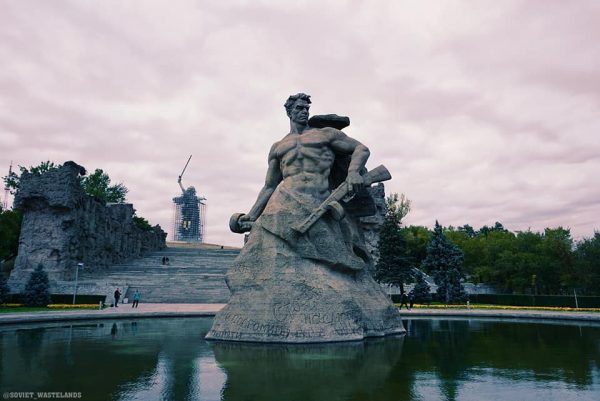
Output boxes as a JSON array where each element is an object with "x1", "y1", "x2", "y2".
[{"x1": 421, "y1": 221, "x2": 467, "y2": 304}]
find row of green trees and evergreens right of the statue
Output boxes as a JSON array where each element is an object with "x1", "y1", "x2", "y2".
[{"x1": 375, "y1": 194, "x2": 600, "y2": 301}]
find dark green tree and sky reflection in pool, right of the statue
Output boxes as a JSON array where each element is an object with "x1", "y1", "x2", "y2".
[{"x1": 405, "y1": 319, "x2": 600, "y2": 401}]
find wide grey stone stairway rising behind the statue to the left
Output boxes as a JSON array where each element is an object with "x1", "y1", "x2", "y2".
[{"x1": 78, "y1": 245, "x2": 240, "y2": 303}]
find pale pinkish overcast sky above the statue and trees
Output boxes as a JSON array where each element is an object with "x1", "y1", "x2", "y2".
[{"x1": 0, "y1": 0, "x2": 600, "y2": 245}]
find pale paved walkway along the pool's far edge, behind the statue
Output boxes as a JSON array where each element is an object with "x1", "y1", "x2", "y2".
[{"x1": 0, "y1": 303, "x2": 600, "y2": 324}]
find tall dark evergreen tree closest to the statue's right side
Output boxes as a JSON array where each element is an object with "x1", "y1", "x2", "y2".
[{"x1": 374, "y1": 194, "x2": 413, "y2": 293}]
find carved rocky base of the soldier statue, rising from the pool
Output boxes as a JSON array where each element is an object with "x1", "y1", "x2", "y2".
[{"x1": 206, "y1": 227, "x2": 405, "y2": 343}]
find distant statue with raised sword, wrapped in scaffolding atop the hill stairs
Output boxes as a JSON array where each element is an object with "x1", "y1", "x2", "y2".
[{"x1": 173, "y1": 155, "x2": 206, "y2": 242}]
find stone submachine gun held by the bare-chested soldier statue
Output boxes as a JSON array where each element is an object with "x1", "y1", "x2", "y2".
[{"x1": 292, "y1": 165, "x2": 392, "y2": 234}]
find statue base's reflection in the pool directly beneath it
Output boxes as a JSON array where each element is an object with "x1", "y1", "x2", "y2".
[{"x1": 213, "y1": 337, "x2": 403, "y2": 401}]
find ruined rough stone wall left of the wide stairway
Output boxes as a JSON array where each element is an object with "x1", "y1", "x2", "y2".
[{"x1": 9, "y1": 162, "x2": 166, "y2": 291}]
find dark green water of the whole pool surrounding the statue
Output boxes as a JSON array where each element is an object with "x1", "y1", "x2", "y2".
[{"x1": 0, "y1": 318, "x2": 600, "y2": 401}]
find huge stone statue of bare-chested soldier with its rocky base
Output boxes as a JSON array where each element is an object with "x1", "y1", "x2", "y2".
[{"x1": 207, "y1": 93, "x2": 405, "y2": 343}]
